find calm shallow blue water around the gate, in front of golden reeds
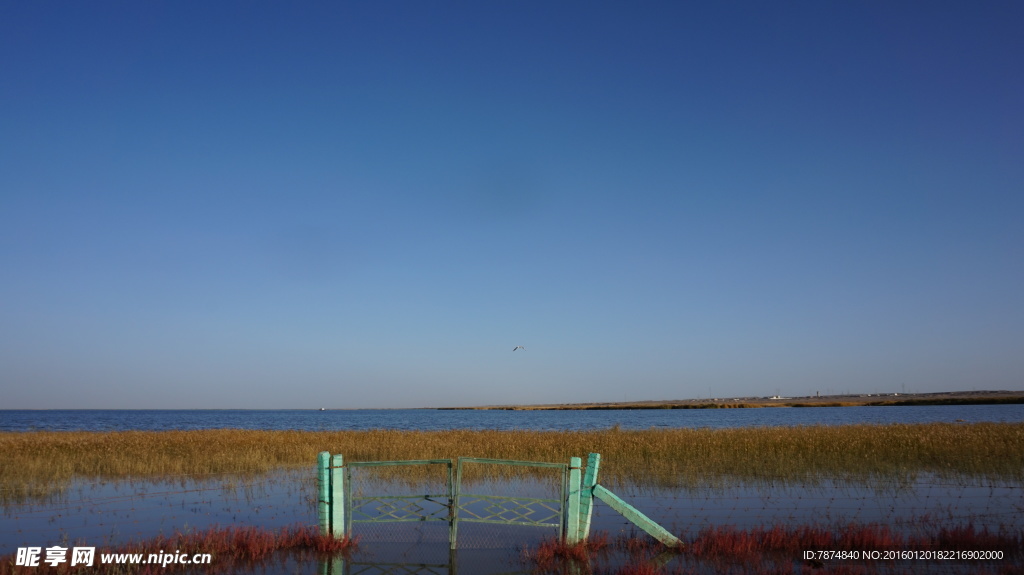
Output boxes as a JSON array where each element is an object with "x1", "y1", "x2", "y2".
[{"x1": 0, "y1": 470, "x2": 1024, "y2": 573}]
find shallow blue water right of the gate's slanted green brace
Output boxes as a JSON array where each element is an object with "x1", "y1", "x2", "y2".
[{"x1": 594, "y1": 474, "x2": 1024, "y2": 533}]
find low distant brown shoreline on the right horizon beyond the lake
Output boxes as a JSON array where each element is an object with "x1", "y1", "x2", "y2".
[{"x1": 434, "y1": 390, "x2": 1024, "y2": 411}]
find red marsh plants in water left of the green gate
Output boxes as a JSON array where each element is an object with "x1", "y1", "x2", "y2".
[{"x1": 0, "y1": 525, "x2": 355, "y2": 575}]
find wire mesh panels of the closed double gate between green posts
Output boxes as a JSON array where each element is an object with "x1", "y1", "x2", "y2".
[{"x1": 346, "y1": 460, "x2": 566, "y2": 574}]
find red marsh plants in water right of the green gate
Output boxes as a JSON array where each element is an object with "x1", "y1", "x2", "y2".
[{"x1": 527, "y1": 524, "x2": 1024, "y2": 575}]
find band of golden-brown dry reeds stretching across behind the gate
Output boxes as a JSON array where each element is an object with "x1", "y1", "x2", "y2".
[{"x1": 0, "y1": 424, "x2": 1024, "y2": 500}]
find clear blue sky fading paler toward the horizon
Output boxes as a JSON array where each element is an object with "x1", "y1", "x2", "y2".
[{"x1": 0, "y1": 0, "x2": 1024, "y2": 408}]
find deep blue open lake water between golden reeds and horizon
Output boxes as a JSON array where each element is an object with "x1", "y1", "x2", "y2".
[{"x1": 0, "y1": 404, "x2": 1024, "y2": 432}]
